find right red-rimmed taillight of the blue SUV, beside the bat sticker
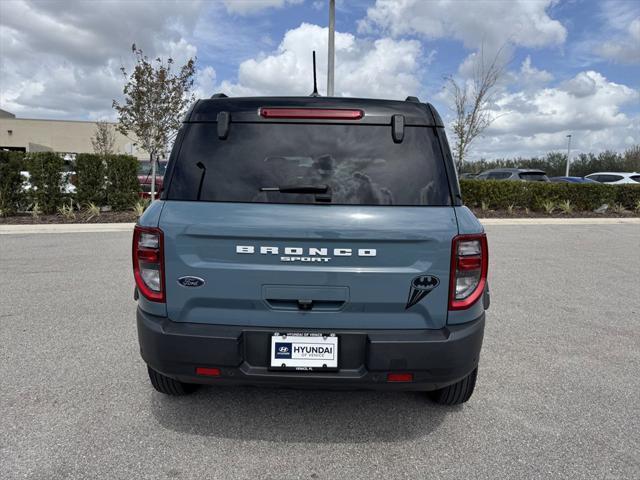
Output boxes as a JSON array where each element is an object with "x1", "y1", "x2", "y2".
[{"x1": 449, "y1": 233, "x2": 489, "y2": 310}]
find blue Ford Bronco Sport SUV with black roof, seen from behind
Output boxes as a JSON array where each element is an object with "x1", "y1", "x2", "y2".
[{"x1": 133, "y1": 94, "x2": 489, "y2": 405}]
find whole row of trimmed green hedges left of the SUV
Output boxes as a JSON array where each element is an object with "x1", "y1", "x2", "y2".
[{"x1": 0, "y1": 151, "x2": 140, "y2": 215}]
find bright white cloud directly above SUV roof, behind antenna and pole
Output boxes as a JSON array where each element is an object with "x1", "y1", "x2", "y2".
[{"x1": 221, "y1": 23, "x2": 422, "y2": 98}]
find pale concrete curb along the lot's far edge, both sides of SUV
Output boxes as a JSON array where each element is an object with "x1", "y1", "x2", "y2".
[{"x1": 0, "y1": 217, "x2": 640, "y2": 235}]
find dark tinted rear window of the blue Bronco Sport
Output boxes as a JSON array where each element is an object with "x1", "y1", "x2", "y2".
[{"x1": 166, "y1": 123, "x2": 451, "y2": 206}]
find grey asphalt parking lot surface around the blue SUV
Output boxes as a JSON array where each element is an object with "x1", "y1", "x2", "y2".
[{"x1": 0, "y1": 224, "x2": 640, "y2": 479}]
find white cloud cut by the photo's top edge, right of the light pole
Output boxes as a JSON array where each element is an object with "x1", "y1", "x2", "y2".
[{"x1": 359, "y1": 0, "x2": 567, "y2": 51}]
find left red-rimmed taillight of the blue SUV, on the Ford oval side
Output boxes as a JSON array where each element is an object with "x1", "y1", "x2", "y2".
[{"x1": 133, "y1": 225, "x2": 165, "y2": 302}]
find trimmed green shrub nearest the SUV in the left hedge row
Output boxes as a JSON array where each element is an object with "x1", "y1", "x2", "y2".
[{"x1": 106, "y1": 155, "x2": 140, "y2": 211}]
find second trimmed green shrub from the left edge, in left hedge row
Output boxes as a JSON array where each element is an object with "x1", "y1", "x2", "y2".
[{"x1": 26, "y1": 152, "x2": 64, "y2": 213}]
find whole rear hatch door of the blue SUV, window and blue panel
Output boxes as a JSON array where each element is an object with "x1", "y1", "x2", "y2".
[{"x1": 160, "y1": 115, "x2": 457, "y2": 329}]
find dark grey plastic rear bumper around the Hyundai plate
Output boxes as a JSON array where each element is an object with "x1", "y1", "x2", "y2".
[{"x1": 137, "y1": 308, "x2": 485, "y2": 390}]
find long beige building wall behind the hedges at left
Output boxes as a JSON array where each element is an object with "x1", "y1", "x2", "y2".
[{"x1": 0, "y1": 109, "x2": 149, "y2": 160}]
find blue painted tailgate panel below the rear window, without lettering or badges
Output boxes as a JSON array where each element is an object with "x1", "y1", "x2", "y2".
[{"x1": 159, "y1": 201, "x2": 458, "y2": 329}]
